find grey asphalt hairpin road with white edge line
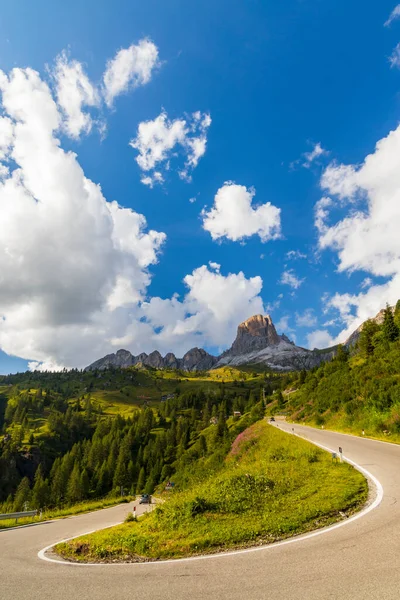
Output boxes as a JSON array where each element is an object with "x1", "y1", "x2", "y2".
[{"x1": 0, "y1": 423, "x2": 400, "y2": 600}]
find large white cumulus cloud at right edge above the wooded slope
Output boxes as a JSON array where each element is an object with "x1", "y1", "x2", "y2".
[{"x1": 318, "y1": 126, "x2": 400, "y2": 341}]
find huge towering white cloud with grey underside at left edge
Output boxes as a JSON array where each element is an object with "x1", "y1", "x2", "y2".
[{"x1": 0, "y1": 64, "x2": 165, "y2": 366}]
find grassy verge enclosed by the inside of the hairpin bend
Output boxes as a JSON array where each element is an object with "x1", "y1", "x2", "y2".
[{"x1": 56, "y1": 420, "x2": 368, "y2": 562}]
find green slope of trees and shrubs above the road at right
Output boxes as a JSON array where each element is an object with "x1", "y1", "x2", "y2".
[{"x1": 283, "y1": 301, "x2": 400, "y2": 434}]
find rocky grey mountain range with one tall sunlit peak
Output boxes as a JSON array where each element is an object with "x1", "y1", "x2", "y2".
[{"x1": 86, "y1": 315, "x2": 335, "y2": 371}]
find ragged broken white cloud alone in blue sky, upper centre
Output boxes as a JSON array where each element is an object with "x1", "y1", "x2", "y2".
[{"x1": 129, "y1": 111, "x2": 211, "y2": 187}]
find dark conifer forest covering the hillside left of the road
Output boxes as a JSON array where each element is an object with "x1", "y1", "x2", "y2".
[{"x1": 0, "y1": 386, "x2": 263, "y2": 512}]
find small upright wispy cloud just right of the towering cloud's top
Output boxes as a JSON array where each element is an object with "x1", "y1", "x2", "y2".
[{"x1": 53, "y1": 52, "x2": 100, "y2": 138}]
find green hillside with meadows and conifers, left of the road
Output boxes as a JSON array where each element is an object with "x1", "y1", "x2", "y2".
[{"x1": 0, "y1": 369, "x2": 279, "y2": 512}]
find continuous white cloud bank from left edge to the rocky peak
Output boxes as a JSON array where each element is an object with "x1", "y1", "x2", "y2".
[{"x1": 0, "y1": 55, "x2": 272, "y2": 369}]
